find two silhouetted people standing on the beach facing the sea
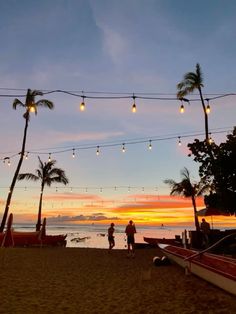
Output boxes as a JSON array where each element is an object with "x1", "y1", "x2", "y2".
[{"x1": 108, "y1": 220, "x2": 136, "y2": 257}]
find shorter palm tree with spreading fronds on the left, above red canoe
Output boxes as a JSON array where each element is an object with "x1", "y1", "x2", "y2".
[{"x1": 18, "y1": 157, "x2": 69, "y2": 231}]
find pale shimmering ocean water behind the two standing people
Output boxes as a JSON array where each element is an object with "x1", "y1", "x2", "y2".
[{"x1": 13, "y1": 224, "x2": 193, "y2": 249}]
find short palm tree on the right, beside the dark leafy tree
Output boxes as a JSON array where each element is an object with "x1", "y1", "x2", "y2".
[{"x1": 164, "y1": 168, "x2": 208, "y2": 231}]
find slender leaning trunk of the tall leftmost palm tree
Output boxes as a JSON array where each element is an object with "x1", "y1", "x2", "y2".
[{"x1": 0, "y1": 112, "x2": 29, "y2": 232}]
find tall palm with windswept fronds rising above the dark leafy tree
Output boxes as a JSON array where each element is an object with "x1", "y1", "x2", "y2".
[{"x1": 177, "y1": 63, "x2": 209, "y2": 143}]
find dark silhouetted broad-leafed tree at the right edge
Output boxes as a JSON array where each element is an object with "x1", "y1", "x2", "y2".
[{"x1": 188, "y1": 127, "x2": 236, "y2": 214}]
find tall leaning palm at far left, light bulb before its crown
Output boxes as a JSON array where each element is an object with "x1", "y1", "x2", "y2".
[{"x1": 0, "y1": 89, "x2": 54, "y2": 232}]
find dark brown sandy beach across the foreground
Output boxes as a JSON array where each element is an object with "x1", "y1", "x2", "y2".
[{"x1": 0, "y1": 248, "x2": 236, "y2": 314}]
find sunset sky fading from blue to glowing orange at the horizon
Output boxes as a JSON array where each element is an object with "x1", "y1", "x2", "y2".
[{"x1": 0, "y1": 0, "x2": 236, "y2": 224}]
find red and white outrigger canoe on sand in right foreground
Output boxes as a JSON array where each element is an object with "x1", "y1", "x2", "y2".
[{"x1": 159, "y1": 244, "x2": 236, "y2": 295}]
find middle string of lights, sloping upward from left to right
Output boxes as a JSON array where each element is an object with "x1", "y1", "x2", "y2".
[{"x1": 0, "y1": 127, "x2": 233, "y2": 162}]
